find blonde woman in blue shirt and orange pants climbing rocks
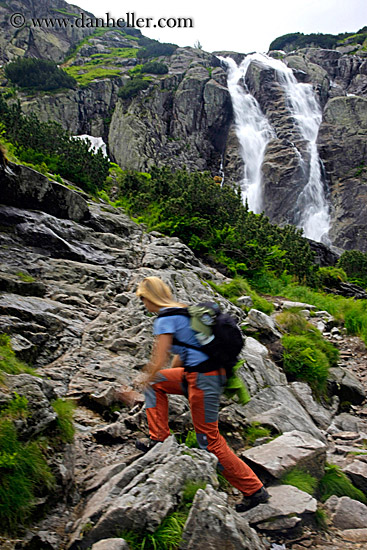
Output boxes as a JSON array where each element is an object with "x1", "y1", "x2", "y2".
[{"x1": 136, "y1": 277, "x2": 269, "y2": 512}]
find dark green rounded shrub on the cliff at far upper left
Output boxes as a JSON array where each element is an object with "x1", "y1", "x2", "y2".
[{"x1": 5, "y1": 57, "x2": 76, "y2": 91}]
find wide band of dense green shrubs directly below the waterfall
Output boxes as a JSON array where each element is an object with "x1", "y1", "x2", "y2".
[{"x1": 116, "y1": 167, "x2": 317, "y2": 283}]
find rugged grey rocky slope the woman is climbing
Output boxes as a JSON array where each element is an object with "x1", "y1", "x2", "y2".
[{"x1": 0, "y1": 157, "x2": 367, "y2": 550}]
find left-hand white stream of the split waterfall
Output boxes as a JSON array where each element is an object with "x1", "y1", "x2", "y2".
[{"x1": 220, "y1": 57, "x2": 275, "y2": 214}]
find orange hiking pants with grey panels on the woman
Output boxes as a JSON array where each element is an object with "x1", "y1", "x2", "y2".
[{"x1": 145, "y1": 368, "x2": 262, "y2": 496}]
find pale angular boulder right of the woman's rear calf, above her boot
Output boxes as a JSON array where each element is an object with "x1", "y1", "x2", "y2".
[{"x1": 242, "y1": 430, "x2": 326, "y2": 479}]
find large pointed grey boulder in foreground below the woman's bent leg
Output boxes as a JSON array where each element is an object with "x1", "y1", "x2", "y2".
[{"x1": 70, "y1": 436, "x2": 218, "y2": 550}]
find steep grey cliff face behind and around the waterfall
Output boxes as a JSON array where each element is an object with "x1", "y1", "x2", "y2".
[{"x1": 0, "y1": 0, "x2": 367, "y2": 251}]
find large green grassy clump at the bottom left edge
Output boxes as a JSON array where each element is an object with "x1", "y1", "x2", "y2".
[{"x1": 0, "y1": 418, "x2": 54, "y2": 533}]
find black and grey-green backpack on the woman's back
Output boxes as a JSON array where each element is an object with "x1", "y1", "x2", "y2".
[{"x1": 158, "y1": 302, "x2": 243, "y2": 378}]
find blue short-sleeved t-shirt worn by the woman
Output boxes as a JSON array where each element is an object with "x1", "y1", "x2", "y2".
[{"x1": 153, "y1": 308, "x2": 209, "y2": 367}]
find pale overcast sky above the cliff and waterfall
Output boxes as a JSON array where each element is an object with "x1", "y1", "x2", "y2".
[{"x1": 70, "y1": 0, "x2": 367, "y2": 53}]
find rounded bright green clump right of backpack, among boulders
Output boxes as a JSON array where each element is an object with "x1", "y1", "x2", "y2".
[{"x1": 282, "y1": 335, "x2": 329, "y2": 393}]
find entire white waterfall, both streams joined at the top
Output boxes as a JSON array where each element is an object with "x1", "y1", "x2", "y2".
[{"x1": 223, "y1": 54, "x2": 330, "y2": 243}]
